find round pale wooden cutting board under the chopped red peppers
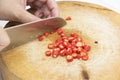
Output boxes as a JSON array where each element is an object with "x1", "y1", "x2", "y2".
[{"x1": 0, "y1": 1, "x2": 120, "y2": 80}]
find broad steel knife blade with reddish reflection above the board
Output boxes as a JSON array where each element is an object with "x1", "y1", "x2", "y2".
[{"x1": 3, "y1": 17, "x2": 66, "y2": 51}]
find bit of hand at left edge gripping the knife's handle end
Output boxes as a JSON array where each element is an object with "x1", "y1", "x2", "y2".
[{"x1": 0, "y1": 29, "x2": 10, "y2": 51}]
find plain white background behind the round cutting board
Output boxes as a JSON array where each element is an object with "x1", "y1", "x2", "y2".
[{"x1": 0, "y1": 0, "x2": 120, "y2": 80}]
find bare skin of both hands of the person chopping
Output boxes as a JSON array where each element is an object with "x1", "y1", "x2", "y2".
[{"x1": 0, "y1": 0, "x2": 59, "y2": 51}]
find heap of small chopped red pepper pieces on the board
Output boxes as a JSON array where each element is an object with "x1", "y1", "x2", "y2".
[{"x1": 42, "y1": 28, "x2": 91, "y2": 62}]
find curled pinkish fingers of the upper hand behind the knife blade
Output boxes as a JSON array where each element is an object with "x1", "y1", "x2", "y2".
[{"x1": 29, "y1": 0, "x2": 59, "y2": 17}]
